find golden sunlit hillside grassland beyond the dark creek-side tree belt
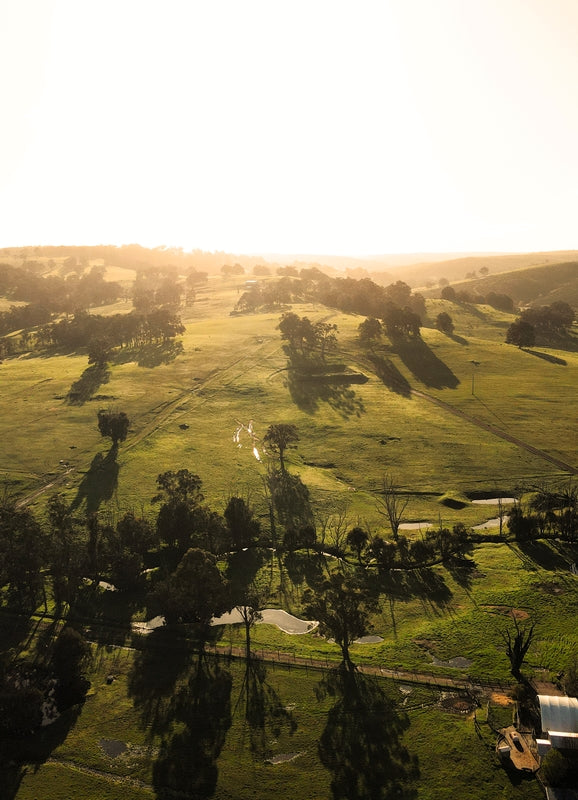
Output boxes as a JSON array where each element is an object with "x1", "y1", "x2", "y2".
[{"x1": 0, "y1": 279, "x2": 578, "y2": 527}]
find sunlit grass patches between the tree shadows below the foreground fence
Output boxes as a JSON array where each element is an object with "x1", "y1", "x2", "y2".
[{"x1": 17, "y1": 651, "x2": 541, "y2": 800}]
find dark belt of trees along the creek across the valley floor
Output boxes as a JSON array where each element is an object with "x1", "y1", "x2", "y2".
[{"x1": 0, "y1": 456, "x2": 560, "y2": 680}]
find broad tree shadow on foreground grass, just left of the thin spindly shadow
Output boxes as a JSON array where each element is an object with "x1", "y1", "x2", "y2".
[{"x1": 152, "y1": 651, "x2": 232, "y2": 800}]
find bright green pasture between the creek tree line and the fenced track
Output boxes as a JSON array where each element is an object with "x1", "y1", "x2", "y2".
[{"x1": 219, "y1": 542, "x2": 578, "y2": 686}]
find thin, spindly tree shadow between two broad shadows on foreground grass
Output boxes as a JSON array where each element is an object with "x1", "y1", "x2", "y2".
[{"x1": 235, "y1": 658, "x2": 297, "y2": 758}]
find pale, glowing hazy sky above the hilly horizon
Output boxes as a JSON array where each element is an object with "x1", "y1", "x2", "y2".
[{"x1": 0, "y1": 0, "x2": 578, "y2": 254}]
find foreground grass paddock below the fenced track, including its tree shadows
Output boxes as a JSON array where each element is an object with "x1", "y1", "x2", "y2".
[{"x1": 16, "y1": 650, "x2": 542, "y2": 800}]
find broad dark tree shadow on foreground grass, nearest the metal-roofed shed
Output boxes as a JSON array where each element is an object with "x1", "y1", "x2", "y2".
[{"x1": 317, "y1": 669, "x2": 419, "y2": 800}]
